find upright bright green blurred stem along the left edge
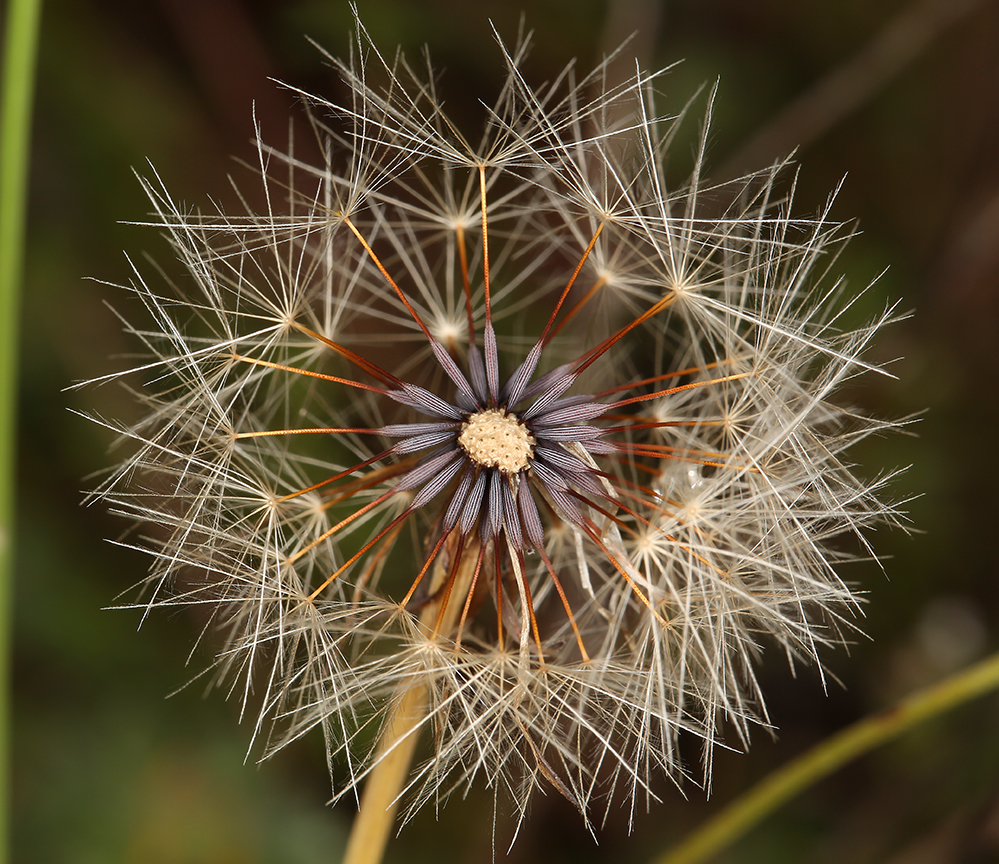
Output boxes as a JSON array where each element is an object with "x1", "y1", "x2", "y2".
[{"x1": 0, "y1": 0, "x2": 42, "y2": 864}]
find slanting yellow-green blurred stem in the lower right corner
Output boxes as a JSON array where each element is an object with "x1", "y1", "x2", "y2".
[{"x1": 653, "y1": 653, "x2": 999, "y2": 864}]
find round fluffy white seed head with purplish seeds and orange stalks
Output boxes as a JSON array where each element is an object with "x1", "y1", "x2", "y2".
[{"x1": 82, "y1": 13, "x2": 895, "y2": 848}]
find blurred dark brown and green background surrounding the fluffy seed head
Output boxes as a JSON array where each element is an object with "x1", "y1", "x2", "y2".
[{"x1": 14, "y1": 0, "x2": 999, "y2": 864}]
